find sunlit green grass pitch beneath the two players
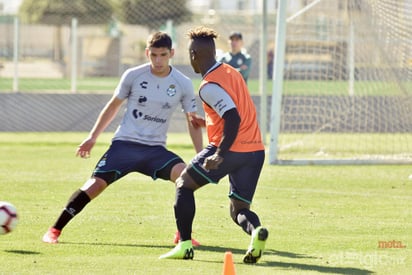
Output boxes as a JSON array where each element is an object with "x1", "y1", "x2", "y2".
[{"x1": 0, "y1": 133, "x2": 412, "y2": 274}]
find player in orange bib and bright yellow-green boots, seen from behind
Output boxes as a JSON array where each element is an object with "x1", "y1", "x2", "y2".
[{"x1": 160, "y1": 27, "x2": 268, "y2": 263}]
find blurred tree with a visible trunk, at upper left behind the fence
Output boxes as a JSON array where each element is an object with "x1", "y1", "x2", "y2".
[{"x1": 20, "y1": 0, "x2": 114, "y2": 61}]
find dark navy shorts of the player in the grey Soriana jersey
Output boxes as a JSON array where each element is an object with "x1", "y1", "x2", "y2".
[{"x1": 93, "y1": 140, "x2": 184, "y2": 184}]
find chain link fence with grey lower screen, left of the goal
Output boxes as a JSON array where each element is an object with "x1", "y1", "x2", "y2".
[{"x1": 0, "y1": 0, "x2": 276, "y2": 131}]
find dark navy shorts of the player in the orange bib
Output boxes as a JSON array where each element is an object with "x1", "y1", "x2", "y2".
[{"x1": 187, "y1": 145, "x2": 265, "y2": 204}]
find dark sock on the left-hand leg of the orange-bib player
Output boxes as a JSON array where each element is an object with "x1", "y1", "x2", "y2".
[{"x1": 174, "y1": 188, "x2": 196, "y2": 241}]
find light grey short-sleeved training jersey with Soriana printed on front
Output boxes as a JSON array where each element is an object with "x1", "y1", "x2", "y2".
[{"x1": 113, "y1": 63, "x2": 197, "y2": 146}]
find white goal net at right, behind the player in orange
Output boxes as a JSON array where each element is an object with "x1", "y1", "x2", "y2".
[{"x1": 270, "y1": 0, "x2": 412, "y2": 164}]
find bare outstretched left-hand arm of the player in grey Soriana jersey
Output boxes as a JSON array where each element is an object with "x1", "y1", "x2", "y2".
[{"x1": 76, "y1": 95, "x2": 123, "y2": 158}]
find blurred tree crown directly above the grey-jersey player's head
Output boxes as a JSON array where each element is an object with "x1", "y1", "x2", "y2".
[{"x1": 119, "y1": 0, "x2": 192, "y2": 30}]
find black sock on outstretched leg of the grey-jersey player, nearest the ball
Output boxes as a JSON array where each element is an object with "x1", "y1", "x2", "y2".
[{"x1": 53, "y1": 189, "x2": 90, "y2": 230}]
